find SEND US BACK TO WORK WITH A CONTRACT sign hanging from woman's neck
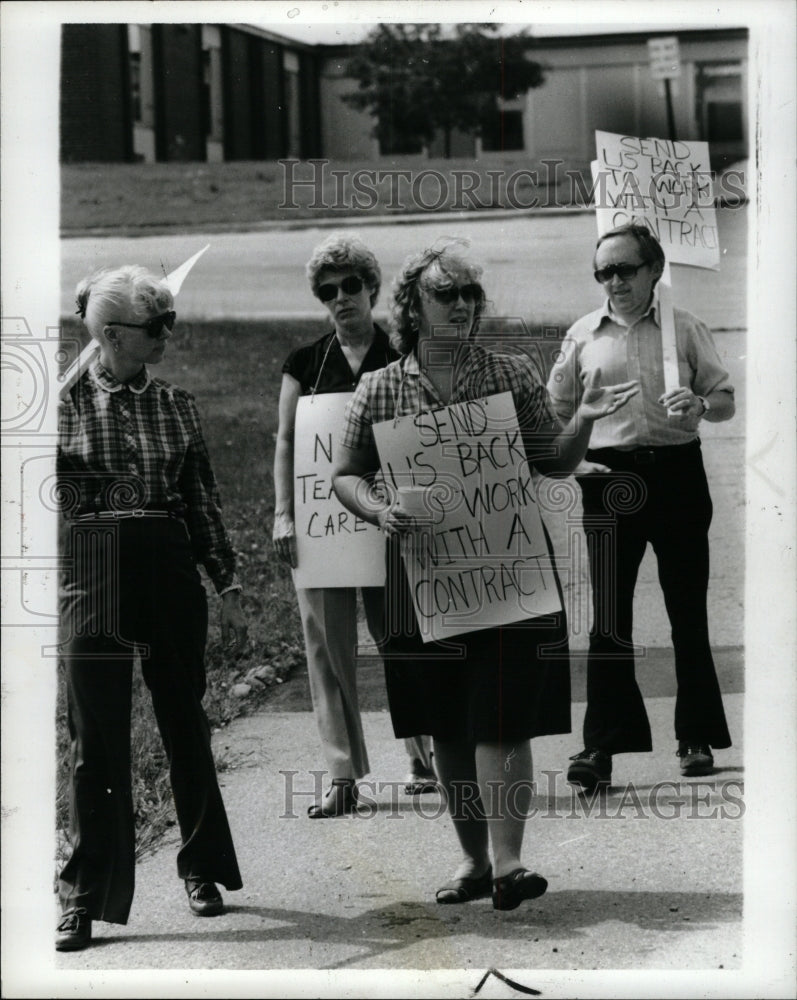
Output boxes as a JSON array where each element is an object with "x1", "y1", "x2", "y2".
[{"x1": 374, "y1": 392, "x2": 561, "y2": 642}]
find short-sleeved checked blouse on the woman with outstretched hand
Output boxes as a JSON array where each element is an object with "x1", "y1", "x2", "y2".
[{"x1": 341, "y1": 344, "x2": 557, "y2": 459}]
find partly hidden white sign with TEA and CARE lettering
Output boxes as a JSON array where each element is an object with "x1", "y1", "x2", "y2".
[{"x1": 293, "y1": 392, "x2": 385, "y2": 587}]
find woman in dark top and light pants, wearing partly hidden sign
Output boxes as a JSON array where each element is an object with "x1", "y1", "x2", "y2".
[{"x1": 273, "y1": 234, "x2": 434, "y2": 819}]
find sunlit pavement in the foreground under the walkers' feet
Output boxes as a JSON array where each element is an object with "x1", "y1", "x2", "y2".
[{"x1": 56, "y1": 694, "x2": 744, "y2": 996}]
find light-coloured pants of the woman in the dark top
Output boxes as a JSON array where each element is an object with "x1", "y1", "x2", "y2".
[{"x1": 296, "y1": 587, "x2": 430, "y2": 778}]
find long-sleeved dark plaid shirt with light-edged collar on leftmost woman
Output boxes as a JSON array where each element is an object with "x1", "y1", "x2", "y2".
[{"x1": 57, "y1": 360, "x2": 239, "y2": 594}]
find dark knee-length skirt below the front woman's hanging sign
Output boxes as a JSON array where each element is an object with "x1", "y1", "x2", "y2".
[{"x1": 380, "y1": 540, "x2": 571, "y2": 743}]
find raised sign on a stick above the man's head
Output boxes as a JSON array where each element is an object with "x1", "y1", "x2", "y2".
[{"x1": 592, "y1": 131, "x2": 720, "y2": 270}]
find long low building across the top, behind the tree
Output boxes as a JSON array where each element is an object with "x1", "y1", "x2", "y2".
[{"x1": 60, "y1": 24, "x2": 750, "y2": 163}]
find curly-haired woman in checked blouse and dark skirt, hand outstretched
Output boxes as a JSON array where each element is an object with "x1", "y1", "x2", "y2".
[{"x1": 333, "y1": 241, "x2": 637, "y2": 910}]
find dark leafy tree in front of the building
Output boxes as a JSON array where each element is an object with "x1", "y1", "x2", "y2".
[{"x1": 342, "y1": 24, "x2": 543, "y2": 157}]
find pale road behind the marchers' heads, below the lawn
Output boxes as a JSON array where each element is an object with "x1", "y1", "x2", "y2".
[{"x1": 61, "y1": 207, "x2": 747, "y2": 330}]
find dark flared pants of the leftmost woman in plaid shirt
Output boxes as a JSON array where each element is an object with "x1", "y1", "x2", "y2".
[{"x1": 59, "y1": 517, "x2": 242, "y2": 924}]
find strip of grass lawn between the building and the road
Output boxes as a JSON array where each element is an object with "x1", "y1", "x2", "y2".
[{"x1": 61, "y1": 154, "x2": 589, "y2": 234}]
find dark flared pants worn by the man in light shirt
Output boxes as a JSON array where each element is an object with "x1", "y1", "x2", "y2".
[{"x1": 578, "y1": 441, "x2": 731, "y2": 754}]
